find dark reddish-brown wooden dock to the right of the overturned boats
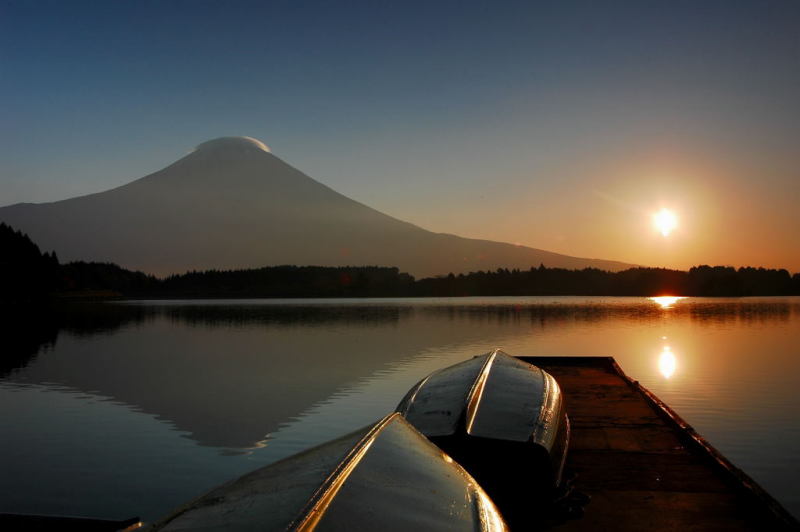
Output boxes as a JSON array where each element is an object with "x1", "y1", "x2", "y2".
[{"x1": 520, "y1": 357, "x2": 800, "y2": 532}]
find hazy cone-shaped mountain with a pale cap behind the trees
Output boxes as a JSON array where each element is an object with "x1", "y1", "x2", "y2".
[{"x1": 0, "y1": 137, "x2": 630, "y2": 277}]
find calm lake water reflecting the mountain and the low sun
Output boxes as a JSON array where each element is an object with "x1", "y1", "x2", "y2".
[{"x1": 0, "y1": 297, "x2": 800, "y2": 520}]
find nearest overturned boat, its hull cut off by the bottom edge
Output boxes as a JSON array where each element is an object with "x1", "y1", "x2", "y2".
[{"x1": 150, "y1": 413, "x2": 507, "y2": 532}]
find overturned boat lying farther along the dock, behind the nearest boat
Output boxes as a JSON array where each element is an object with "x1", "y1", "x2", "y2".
[{"x1": 397, "y1": 350, "x2": 569, "y2": 527}]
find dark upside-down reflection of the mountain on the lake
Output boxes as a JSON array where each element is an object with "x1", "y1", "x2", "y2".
[{"x1": 1, "y1": 303, "x2": 512, "y2": 454}]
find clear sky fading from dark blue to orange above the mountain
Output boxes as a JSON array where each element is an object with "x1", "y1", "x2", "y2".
[{"x1": 0, "y1": 0, "x2": 800, "y2": 272}]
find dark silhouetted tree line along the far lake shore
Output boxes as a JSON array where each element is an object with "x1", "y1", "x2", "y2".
[{"x1": 0, "y1": 223, "x2": 800, "y2": 300}]
